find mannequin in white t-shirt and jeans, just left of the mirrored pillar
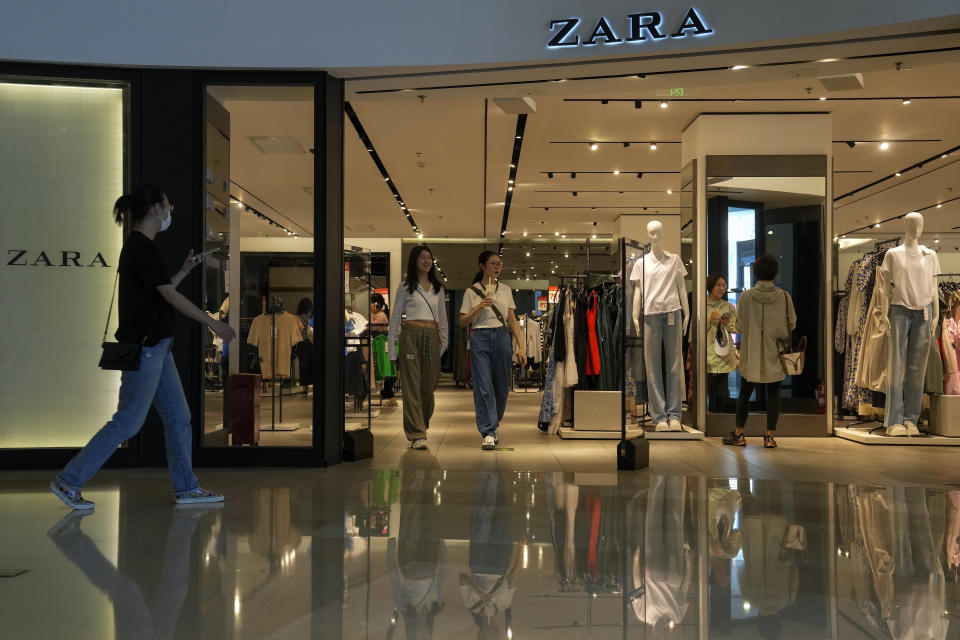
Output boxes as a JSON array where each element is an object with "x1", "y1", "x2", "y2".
[{"x1": 630, "y1": 220, "x2": 690, "y2": 431}]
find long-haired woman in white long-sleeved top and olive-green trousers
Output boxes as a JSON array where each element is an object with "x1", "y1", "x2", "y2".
[{"x1": 387, "y1": 245, "x2": 449, "y2": 449}]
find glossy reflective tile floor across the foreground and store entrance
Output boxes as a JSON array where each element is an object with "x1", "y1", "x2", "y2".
[{"x1": 0, "y1": 382, "x2": 960, "y2": 640}]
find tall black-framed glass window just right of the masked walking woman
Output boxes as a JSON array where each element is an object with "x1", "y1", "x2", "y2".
[{"x1": 203, "y1": 85, "x2": 315, "y2": 447}]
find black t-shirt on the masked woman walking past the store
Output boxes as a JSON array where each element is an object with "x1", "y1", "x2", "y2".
[{"x1": 116, "y1": 231, "x2": 173, "y2": 347}]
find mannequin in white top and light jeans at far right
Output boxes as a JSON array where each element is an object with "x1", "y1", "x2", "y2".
[{"x1": 878, "y1": 212, "x2": 940, "y2": 436}]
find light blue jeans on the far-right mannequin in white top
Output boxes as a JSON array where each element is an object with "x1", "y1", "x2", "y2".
[{"x1": 883, "y1": 303, "x2": 933, "y2": 427}]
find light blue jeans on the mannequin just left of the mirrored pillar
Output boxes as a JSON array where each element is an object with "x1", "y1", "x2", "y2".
[{"x1": 643, "y1": 310, "x2": 683, "y2": 424}]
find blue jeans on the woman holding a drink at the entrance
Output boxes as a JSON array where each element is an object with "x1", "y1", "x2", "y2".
[{"x1": 470, "y1": 327, "x2": 513, "y2": 436}]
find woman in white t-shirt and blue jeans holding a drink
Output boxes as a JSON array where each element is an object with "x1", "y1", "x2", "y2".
[{"x1": 460, "y1": 251, "x2": 527, "y2": 451}]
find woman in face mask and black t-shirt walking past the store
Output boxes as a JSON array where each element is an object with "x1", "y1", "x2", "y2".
[{"x1": 50, "y1": 185, "x2": 236, "y2": 509}]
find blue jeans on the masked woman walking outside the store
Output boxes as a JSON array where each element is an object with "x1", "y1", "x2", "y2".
[{"x1": 57, "y1": 338, "x2": 200, "y2": 495}]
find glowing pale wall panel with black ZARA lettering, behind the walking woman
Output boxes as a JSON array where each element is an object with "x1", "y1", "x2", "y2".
[{"x1": 0, "y1": 78, "x2": 128, "y2": 448}]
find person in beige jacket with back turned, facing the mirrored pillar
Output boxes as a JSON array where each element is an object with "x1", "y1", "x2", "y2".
[{"x1": 723, "y1": 255, "x2": 797, "y2": 449}]
